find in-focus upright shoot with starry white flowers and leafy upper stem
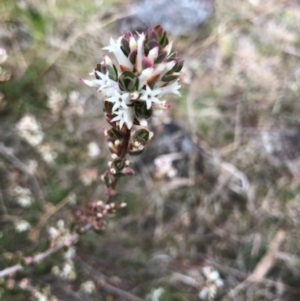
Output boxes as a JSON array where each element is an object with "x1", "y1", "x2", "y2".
[{"x1": 83, "y1": 25, "x2": 183, "y2": 176}]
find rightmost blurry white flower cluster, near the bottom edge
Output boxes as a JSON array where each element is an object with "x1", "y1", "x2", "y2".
[{"x1": 198, "y1": 266, "x2": 224, "y2": 300}]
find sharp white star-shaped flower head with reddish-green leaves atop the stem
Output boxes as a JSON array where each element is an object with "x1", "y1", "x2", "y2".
[{"x1": 83, "y1": 26, "x2": 182, "y2": 129}]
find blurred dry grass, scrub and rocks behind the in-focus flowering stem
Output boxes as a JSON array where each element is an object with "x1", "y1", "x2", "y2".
[{"x1": 0, "y1": 0, "x2": 300, "y2": 301}]
